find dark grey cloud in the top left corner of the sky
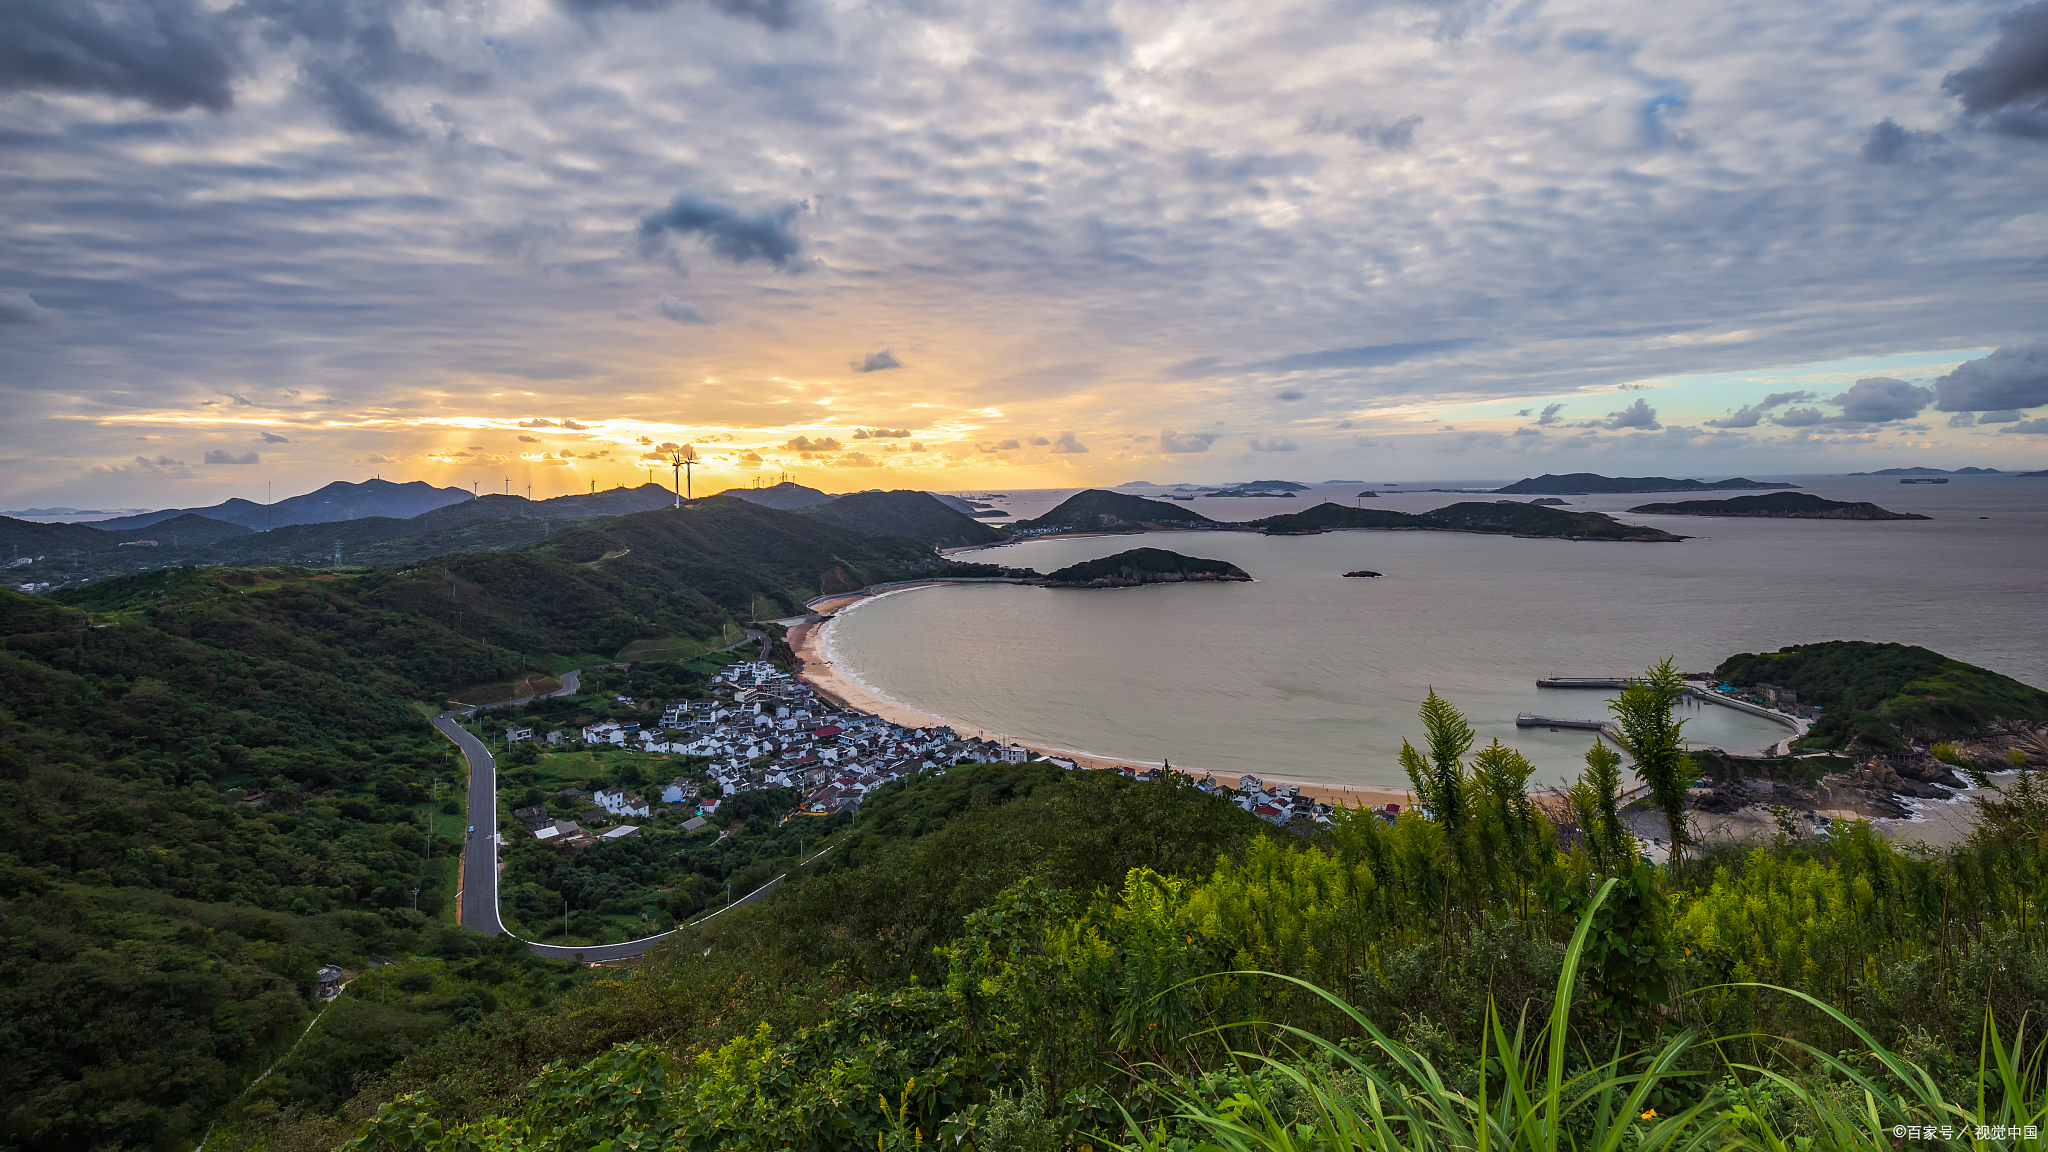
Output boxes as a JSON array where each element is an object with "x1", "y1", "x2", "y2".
[{"x1": 0, "y1": 0, "x2": 240, "y2": 113}]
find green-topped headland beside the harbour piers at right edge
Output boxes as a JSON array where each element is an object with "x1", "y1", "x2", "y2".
[{"x1": 1714, "y1": 640, "x2": 2048, "y2": 748}]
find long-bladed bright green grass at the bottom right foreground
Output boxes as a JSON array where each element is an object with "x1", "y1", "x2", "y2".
[{"x1": 1118, "y1": 879, "x2": 2048, "y2": 1152}]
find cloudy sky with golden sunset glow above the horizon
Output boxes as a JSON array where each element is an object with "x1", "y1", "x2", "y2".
[{"x1": 0, "y1": 0, "x2": 2048, "y2": 508}]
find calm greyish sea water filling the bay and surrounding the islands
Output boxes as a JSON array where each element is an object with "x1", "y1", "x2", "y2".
[{"x1": 825, "y1": 478, "x2": 2048, "y2": 785}]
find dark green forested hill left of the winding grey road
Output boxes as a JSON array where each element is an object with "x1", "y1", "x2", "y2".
[{"x1": 0, "y1": 498, "x2": 958, "y2": 1150}]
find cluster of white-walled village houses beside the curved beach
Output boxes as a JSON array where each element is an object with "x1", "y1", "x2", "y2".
[{"x1": 487, "y1": 662, "x2": 1331, "y2": 851}]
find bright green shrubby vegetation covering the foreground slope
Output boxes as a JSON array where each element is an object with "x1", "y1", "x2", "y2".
[{"x1": 307, "y1": 672, "x2": 2048, "y2": 1152}]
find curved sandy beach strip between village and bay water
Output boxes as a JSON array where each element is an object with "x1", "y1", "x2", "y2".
[{"x1": 788, "y1": 582, "x2": 1415, "y2": 808}]
